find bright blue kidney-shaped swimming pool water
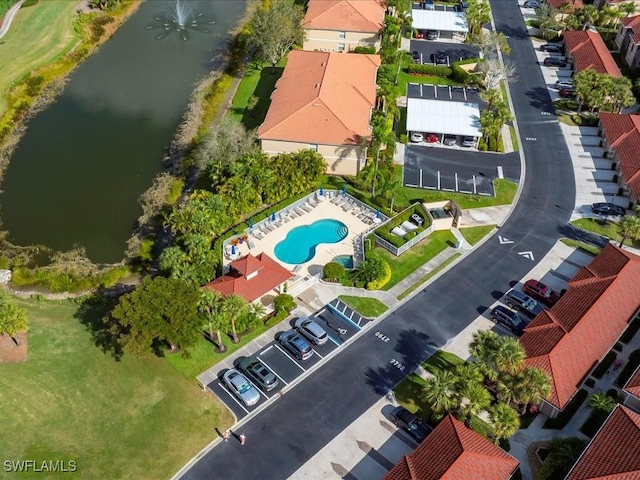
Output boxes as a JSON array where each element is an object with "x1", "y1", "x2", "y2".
[{"x1": 274, "y1": 219, "x2": 349, "y2": 264}]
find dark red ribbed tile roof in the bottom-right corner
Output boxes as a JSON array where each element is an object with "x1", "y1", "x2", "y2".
[{"x1": 566, "y1": 405, "x2": 640, "y2": 480}]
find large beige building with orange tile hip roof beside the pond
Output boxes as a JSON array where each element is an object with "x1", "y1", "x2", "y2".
[{"x1": 258, "y1": 51, "x2": 380, "y2": 175}]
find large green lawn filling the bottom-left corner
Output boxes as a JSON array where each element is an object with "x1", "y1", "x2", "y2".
[{"x1": 0, "y1": 298, "x2": 232, "y2": 479}]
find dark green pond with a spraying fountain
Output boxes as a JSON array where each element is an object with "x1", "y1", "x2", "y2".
[{"x1": 0, "y1": 0, "x2": 246, "y2": 262}]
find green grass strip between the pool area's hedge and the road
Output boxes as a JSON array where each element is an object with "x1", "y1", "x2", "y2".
[{"x1": 376, "y1": 230, "x2": 456, "y2": 290}]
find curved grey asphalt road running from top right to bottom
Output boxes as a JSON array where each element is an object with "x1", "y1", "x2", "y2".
[{"x1": 183, "y1": 0, "x2": 575, "y2": 480}]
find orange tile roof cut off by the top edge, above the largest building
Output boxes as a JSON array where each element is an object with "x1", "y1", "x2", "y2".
[{"x1": 302, "y1": 0, "x2": 386, "y2": 33}]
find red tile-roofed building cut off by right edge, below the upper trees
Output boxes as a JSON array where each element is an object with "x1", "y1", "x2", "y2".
[{"x1": 599, "y1": 112, "x2": 640, "y2": 207}]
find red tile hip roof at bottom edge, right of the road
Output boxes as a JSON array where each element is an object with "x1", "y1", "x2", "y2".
[{"x1": 384, "y1": 415, "x2": 519, "y2": 480}]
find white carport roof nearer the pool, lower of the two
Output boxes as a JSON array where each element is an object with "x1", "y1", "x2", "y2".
[{"x1": 407, "y1": 98, "x2": 482, "y2": 146}]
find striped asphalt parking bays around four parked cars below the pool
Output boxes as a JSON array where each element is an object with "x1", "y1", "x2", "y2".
[{"x1": 207, "y1": 299, "x2": 370, "y2": 420}]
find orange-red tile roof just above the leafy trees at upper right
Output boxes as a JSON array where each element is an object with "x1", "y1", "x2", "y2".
[{"x1": 562, "y1": 30, "x2": 622, "y2": 77}]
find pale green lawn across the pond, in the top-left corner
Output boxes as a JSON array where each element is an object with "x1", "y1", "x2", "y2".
[{"x1": 0, "y1": 1, "x2": 79, "y2": 115}]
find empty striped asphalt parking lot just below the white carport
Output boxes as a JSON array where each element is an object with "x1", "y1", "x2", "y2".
[{"x1": 403, "y1": 145, "x2": 520, "y2": 195}]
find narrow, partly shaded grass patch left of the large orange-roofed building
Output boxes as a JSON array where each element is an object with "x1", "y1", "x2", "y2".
[{"x1": 229, "y1": 57, "x2": 286, "y2": 129}]
